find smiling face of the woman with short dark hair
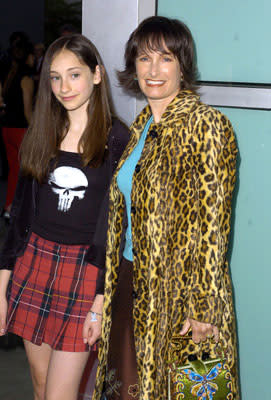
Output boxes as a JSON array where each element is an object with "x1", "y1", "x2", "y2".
[{"x1": 136, "y1": 47, "x2": 182, "y2": 106}]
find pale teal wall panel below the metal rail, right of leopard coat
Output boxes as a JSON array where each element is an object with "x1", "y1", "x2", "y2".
[{"x1": 222, "y1": 109, "x2": 271, "y2": 400}]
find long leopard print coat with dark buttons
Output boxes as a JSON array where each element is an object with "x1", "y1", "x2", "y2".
[{"x1": 93, "y1": 91, "x2": 239, "y2": 400}]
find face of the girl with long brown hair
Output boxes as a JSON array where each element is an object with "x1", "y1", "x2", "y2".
[{"x1": 50, "y1": 49, "x2": 101, "y2": 111}]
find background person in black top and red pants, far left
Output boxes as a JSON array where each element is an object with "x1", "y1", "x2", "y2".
[{"x1": 1, "y1": 32, "x2": 34, "y2": 221}]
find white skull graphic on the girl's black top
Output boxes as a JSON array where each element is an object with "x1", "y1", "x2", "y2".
[{"x1": 48, "y1": 167, "x2": 88, "y2": 212}]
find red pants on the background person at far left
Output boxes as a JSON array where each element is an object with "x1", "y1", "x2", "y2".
[{"x1": 2, "y1": 127, "x2": 26, "y2": 209}]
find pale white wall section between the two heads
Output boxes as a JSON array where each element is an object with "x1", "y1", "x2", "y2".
[{"x1": 82, "y1": 0, "x2": 156, "y2": 125}]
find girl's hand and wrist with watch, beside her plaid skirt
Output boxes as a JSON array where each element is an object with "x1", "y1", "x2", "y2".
[{"x1": 83, "y1": 294, "x2": 104, "y2": 346}]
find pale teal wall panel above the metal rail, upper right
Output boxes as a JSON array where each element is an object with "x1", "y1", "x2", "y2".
[{"x1": 158, "y1": 0, "x2": 271, "y2": 83}]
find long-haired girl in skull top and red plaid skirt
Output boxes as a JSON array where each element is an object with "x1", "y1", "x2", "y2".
[{"x1": 0, "y1": 34, "x2": 129, "y2": 400}]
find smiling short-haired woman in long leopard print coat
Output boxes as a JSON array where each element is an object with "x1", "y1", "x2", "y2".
[{"x1": 92, "y1": 17, "x2": 238, "y2": 400}]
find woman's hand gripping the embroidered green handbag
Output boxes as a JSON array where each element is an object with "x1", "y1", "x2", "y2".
[{"x1": 180, "y1": 318, "x2": 219, "y2": 344}]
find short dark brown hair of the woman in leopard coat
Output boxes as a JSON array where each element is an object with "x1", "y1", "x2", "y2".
[{"x1": 117, "y1": 16, "x2": 197, "y2": 94}]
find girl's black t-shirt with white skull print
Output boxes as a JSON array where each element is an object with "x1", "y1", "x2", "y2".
[{"x1": 33, "y1": 151, "x2": 109, "y2": 244}]
